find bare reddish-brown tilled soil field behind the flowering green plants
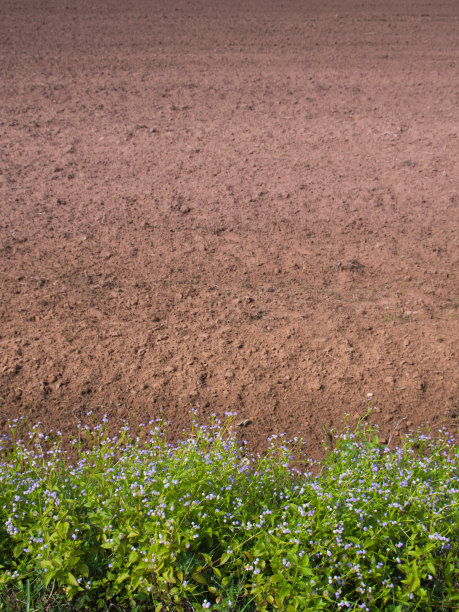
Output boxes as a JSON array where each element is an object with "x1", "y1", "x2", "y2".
[{"x1": 0, "y1": 0, "x2": 459, "y2": 453}]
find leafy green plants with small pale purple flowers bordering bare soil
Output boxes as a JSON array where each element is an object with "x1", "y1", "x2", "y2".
[{"x1": 0, "y1": 415, "x2": 459, "y2": 612}]
